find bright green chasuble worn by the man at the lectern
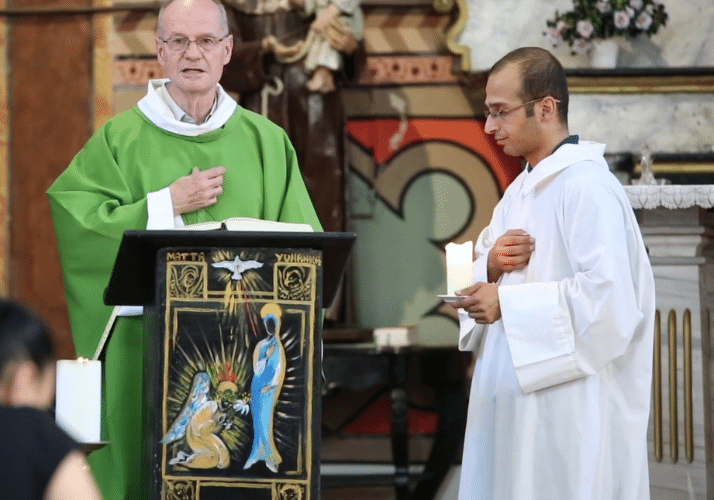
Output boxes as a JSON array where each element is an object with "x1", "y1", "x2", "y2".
[{"x1": 48, "y1": 106, "x2": 322, "y2": 500}]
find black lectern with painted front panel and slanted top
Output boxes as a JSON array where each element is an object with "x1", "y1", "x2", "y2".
[{"x1": 105, "y1": 230, "x2": 355, "y2": 500}]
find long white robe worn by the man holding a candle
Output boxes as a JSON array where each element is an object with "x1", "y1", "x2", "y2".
[{"x1": 459, "y1": 141, "x2": 655, "y2": 500}]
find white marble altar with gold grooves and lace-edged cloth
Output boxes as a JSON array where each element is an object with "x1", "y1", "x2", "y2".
[{"x1": 625, "y1": 185, "x2": 714, "y2": 500}]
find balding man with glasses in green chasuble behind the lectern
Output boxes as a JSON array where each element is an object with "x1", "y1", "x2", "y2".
[{"x1": 48, "y1": 0, "x2": 322, "y2": 500}]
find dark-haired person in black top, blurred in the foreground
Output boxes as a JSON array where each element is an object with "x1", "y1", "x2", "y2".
[{"x1": 0, "y1": 300, "x2": 101, "y2": 500}]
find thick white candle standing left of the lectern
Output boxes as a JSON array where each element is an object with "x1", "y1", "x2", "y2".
[{"x1": 55, "y1": 358, "x2": 102, "y2": 443}]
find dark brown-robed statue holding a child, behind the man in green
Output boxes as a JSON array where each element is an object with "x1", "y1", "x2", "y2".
[{"x1": 221, "y1": 0, "x2": 362, "y2": 231}]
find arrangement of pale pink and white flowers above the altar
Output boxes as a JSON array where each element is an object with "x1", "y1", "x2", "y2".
[{"x1": 543, "y1": 0, "x2": 669, "y2": 54}]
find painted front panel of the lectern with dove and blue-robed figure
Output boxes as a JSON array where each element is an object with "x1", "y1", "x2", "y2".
[{"x1": 150, "y1": 248, "x2": 322, "y2": 500}]
